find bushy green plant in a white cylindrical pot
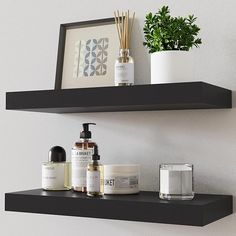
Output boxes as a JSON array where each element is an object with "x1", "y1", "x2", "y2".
[{"x1": 143, "y1": 6, "x2": 202, "y2": 84}]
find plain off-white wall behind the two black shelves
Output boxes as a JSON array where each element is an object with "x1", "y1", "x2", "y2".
[{"x1": 0, "y1": 0, "x2": 236, "y2": 236}]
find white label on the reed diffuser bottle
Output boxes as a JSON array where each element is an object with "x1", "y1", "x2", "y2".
[{"x1": 115, "y1": 62, "x2": 134, "y2": 85}]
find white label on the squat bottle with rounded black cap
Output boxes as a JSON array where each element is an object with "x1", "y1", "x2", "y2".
[{"x1": 42, "y1": 164, "x2": 65, "y2": 189}]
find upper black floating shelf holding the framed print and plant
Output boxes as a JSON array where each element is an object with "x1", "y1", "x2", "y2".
[{"x1": 6, "y1": 82, "x2": 232, "y2": 113}]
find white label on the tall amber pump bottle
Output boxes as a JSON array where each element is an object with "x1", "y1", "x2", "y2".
[{"x1": 71, "y1": 149, "x2": 93, "y2": 187}]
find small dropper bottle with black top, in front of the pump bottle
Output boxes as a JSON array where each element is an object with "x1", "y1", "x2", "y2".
[{"x1": 87, "y1": 145, "x2": 104, "y2": 197}]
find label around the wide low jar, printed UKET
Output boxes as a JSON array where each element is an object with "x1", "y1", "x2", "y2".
[{"x1": 104, "y1": 176, "x2": 139, "y2": 190}]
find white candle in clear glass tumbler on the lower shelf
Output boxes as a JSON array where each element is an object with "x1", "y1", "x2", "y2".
[{"x1": 159, "y1": 164, "x2": 194, "y2": 200}]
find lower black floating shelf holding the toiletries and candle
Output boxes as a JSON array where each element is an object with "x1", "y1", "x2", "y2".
[{"x1": 5, "y1": 189, "x2": 233, "y2": 226}]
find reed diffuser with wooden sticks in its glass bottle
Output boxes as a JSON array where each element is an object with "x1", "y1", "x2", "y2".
[{"x1": 114, "y1": 11, "x2": 135, "y2": 86}]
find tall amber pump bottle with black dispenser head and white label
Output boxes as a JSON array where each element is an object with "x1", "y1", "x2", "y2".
[{"x1": 71, "y1": 123, "x2": 96, "y2": 192}]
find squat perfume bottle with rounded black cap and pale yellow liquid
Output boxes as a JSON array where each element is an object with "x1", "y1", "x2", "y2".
[{"x1": 42, "y1": 146, "x2": 71, "y2": 190}]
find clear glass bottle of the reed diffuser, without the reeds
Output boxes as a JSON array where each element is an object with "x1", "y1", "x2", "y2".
[{"x1": 115, "y1": 49, "x2": 134, "y2": 86}]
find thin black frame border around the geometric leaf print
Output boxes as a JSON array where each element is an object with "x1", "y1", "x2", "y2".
[{"x1": 54, "y1": 17, "x2": 115, "y2": 90}]
